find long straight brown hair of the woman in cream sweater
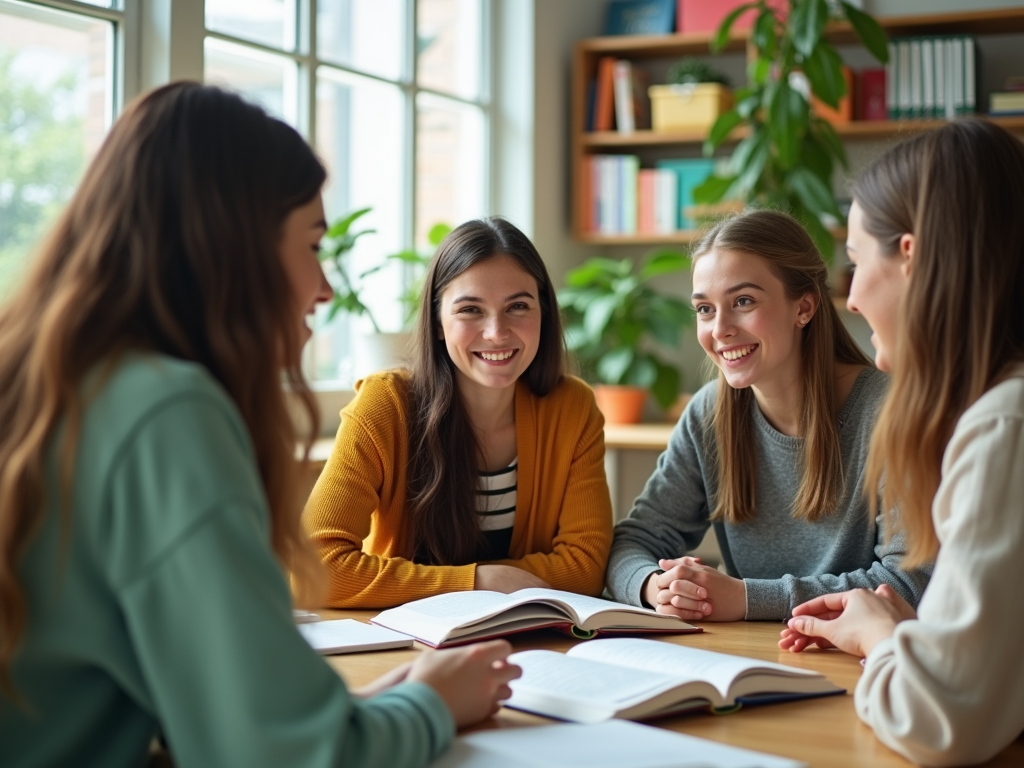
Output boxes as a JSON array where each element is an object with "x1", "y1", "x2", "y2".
[{"x1": 853, "y1": 120, "x2": 1024, "y2": 567}]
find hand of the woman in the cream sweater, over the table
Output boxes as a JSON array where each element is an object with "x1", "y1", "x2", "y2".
[{"x1": 778, "y1": 584, "x2": 918, "y2": 656}]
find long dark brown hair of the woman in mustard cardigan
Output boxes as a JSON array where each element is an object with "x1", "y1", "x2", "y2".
[{"x1": 408, "y1": 217, "x2": 565, "y2": 565}]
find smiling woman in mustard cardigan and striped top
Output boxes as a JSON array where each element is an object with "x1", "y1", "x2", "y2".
[{"x1": 306, "y1": 218, "x2": 611, "y2": 607}]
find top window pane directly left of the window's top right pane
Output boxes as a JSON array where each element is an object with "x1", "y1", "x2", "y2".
[{"x1": 316, "y1": 0, "x2": 406, "y2": 80}]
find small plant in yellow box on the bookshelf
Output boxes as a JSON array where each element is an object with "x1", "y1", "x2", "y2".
[{"x1": 647, "y1": 56, "x2": 732, "y2": 131}]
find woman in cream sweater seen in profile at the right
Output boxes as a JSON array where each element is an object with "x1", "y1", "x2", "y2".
[{"x1": 779, "y1": 121, "x2": 1024, "y2": 765}]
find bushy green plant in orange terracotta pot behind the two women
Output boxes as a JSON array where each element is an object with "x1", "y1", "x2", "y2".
[{"x1": 558, "y1": 250, "x2": 693, "y2": 423}]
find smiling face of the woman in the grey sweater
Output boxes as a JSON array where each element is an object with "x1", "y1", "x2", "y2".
[{"x1": 692, "y1": 249, "x2": 816, "y2": 389}]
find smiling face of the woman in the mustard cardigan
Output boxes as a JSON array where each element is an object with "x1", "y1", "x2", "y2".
[{"x1": 439, "y1": 255, "x2": 541, "y2": 393}]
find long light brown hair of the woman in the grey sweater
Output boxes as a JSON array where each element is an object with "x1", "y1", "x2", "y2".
[{"x1": 693, "y1": 210, "x2": 872, "y2": 523}]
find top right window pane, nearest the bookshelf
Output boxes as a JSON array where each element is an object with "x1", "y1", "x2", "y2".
[{"x1": 416, "y1": 0, "x2": 483, "y2": 98}]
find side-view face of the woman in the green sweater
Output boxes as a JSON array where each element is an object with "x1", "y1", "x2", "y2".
[{"x1": 279, "y1": 195, "x2": 334, "y2": 358}]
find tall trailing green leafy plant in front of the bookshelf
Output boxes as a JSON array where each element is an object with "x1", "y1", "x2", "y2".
[{"x1": 694, "y1": 0, "x2": 889, "y2": 258}]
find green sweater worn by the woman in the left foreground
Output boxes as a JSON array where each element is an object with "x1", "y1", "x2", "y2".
[{"x1": 0, "y1": 355, "x2": 455, "y2": 768}]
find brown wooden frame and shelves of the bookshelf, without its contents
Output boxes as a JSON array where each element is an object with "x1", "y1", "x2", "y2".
[{"x1": 571, "y1": 7, "x2": 1024, "y2": 246}]
